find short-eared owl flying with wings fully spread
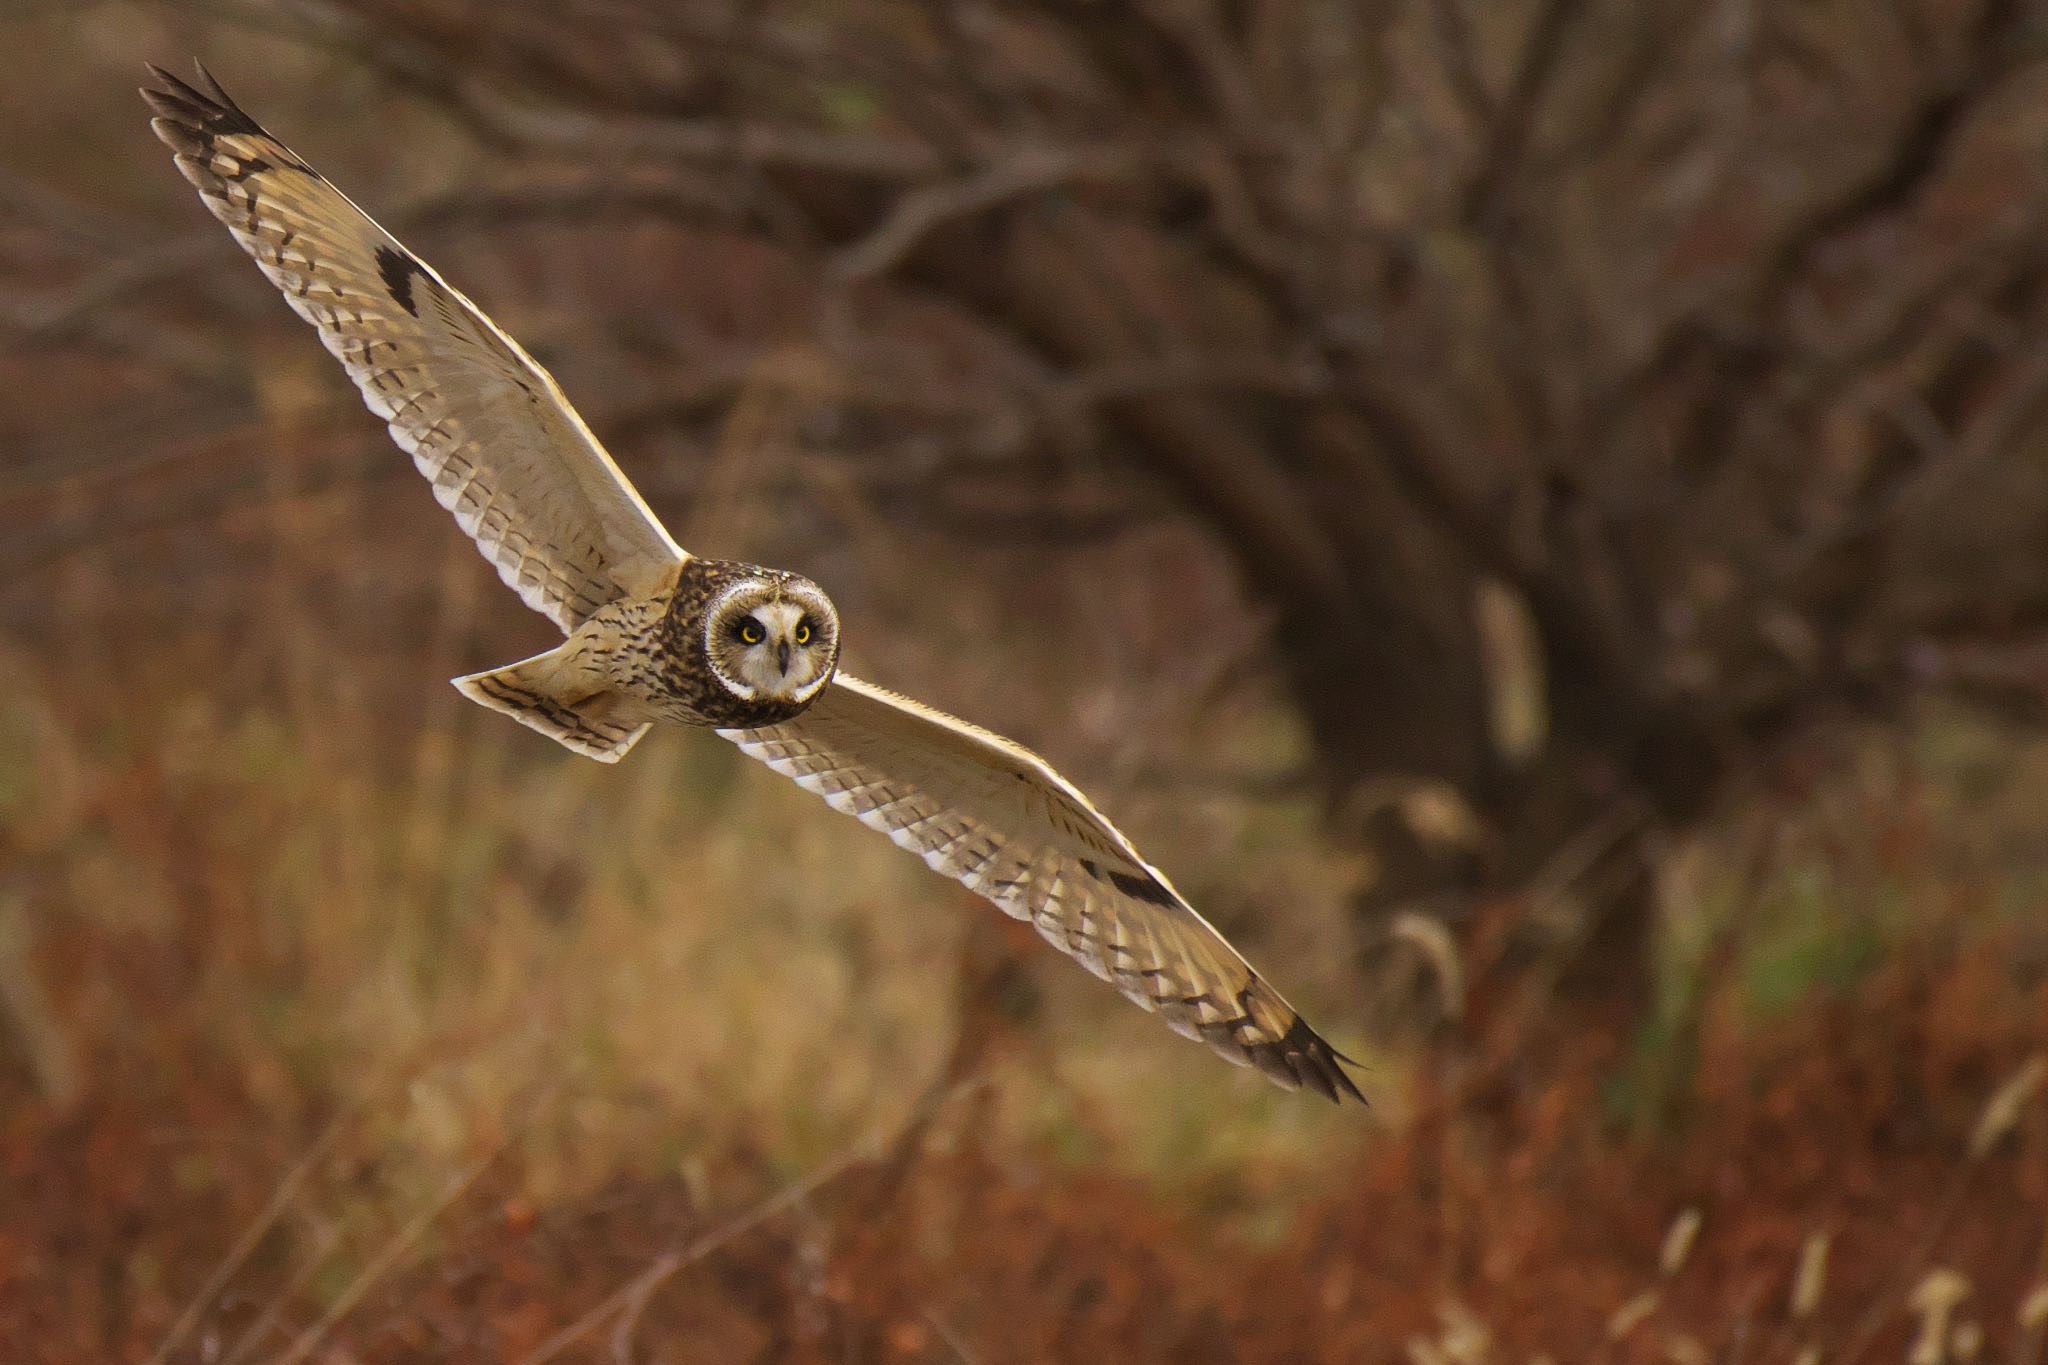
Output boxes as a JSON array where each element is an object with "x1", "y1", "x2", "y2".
[{"x1": 141, "y1": 68, "x2": 1362, "y2": 1099}]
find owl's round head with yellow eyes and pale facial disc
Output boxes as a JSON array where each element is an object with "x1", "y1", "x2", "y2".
[{"x1": 705, "y1": 573, "x2": 840, "y2": 704}]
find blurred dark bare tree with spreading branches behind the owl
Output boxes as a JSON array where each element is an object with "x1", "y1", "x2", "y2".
[{"x1": 12, "y1": 0, "x2": 2048, "y2": 982}]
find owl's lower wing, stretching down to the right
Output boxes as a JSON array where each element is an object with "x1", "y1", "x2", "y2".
[{"x1": 719, "y1": 673, "x2": 1362, "y2": 1099}]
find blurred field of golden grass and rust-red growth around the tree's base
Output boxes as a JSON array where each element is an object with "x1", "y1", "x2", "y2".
[{"x1": 0, "y1": 6, "x2": 2048, "y2": 1365}]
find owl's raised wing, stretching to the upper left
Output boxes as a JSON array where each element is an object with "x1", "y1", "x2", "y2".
[{"x1": 141, "y1": 65, "x2": 688, "y2": 632}]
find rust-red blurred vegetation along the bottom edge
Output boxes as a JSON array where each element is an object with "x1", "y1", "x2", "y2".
[{"x1": 0, "y1": 945, "x2": 2048, "y2": 1361}]
